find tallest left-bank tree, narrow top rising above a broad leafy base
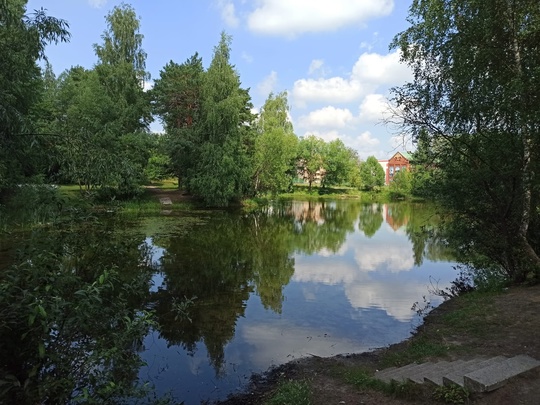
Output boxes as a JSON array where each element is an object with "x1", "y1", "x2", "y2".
[{"x1": 52, "y1": 4, "x2": 151, "y2": 199}]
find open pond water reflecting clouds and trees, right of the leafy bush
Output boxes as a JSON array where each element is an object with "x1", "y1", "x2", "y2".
[{"x1": 134, "y1": 201, "x2": 456, "y2": 405}]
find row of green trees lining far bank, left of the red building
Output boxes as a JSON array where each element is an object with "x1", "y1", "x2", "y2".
[{"x1": 0, "y1": 0, "x2": 394, "y2": 206}]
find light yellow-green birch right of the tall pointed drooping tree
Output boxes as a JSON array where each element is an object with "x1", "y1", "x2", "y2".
[{"x1": 253, "y1": 92, "x2": 298, "y2": 194}]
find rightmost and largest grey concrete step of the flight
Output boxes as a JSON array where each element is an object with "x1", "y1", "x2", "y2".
[{"x1": 463, "y1": 355, "x2": 540, "y2": 392}]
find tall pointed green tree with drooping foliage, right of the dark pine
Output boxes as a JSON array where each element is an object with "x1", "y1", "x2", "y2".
[{"x1": 189, "y1": 32, "x2": 254, "y2": 206}]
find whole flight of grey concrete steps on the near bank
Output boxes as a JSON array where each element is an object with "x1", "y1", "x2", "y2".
[{"x1": 375, "y1": 355, "x2": 540, "y2": 392}]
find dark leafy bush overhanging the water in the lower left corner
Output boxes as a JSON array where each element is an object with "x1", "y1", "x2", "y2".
[{"x1": 0, "y1": 216, "x2": 160, "y2": 404}]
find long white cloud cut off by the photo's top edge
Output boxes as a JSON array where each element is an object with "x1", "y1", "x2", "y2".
[{"x1": 248, "y1": 0, "x2": 394, "y2": 38}]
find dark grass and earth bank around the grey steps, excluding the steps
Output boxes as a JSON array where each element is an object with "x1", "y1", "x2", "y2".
[{"x1": 226, "y1": 286, "x2": 540, "y2": 405}]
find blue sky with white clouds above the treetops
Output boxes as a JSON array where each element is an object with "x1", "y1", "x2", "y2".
[{"x1": 28, "y1": 0, "x2": 411, "y2": 159}]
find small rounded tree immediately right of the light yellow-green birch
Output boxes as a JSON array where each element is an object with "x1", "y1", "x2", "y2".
[{"x1": 297, "y1": 135, "x2": 326, "y2": 190}]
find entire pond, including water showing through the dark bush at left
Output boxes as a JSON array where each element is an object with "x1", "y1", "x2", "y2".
[{"x1": 0, "y1": 200, "x2": 457, "y2": 405}]
